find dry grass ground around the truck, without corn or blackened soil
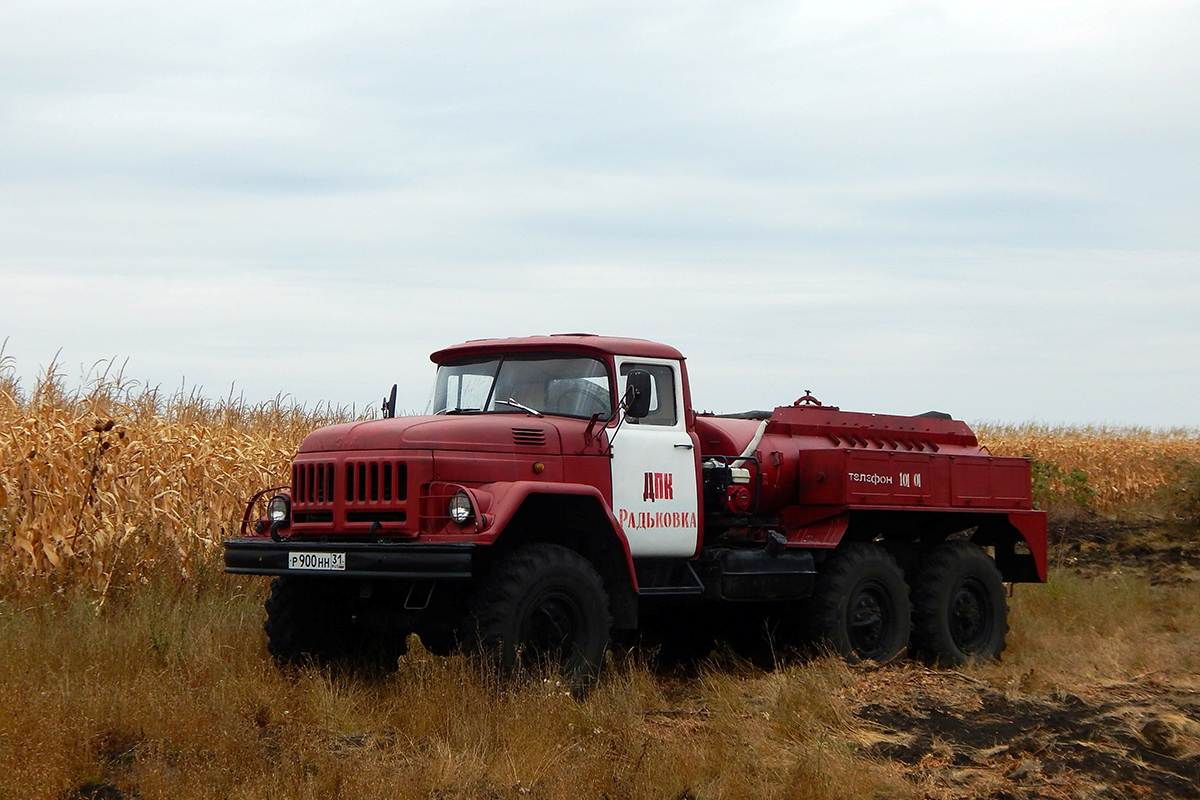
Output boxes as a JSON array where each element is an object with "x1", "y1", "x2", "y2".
[{"x1": 0, "y1": 575, "x2": 1200, "y2": 800}]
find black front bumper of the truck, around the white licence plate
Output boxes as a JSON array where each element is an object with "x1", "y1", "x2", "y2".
[{"x1": 224, "y1": 539, "x2": 475, "y2": 581}]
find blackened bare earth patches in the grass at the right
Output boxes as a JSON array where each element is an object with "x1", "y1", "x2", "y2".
[{"x1": 850, "y1": 521, "x2": 1200, "y2": 800}]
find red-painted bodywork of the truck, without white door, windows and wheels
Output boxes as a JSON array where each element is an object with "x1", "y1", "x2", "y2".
[{"x1": 241, "y1": 335, "x2": 1046, "y2": 579}]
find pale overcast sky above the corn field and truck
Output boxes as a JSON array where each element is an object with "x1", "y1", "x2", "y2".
[{"x1": 0, "y1": 0, "x2": 1200, "y2": 428}]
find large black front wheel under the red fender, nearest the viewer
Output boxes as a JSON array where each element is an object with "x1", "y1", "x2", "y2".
[{"x1": 467, "y1": 543, "x2": 612, "y2": 693}]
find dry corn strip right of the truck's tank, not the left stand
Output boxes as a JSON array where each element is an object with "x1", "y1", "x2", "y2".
[{"x1": 976, "y1": 423, "x2": 1200, "y2": 511}]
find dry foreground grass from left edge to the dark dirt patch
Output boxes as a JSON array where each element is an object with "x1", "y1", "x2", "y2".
[{"x1": 0, "y1": 585, "x2": 908, "y2": 800}]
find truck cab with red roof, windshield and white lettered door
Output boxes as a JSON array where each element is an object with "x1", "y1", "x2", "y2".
[{"x1": 430, "y1": 336, "x2": 702, "y2": 558}]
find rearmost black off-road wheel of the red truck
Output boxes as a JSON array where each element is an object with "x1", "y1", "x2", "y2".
[{"x1": 912, "y1": 541, "x2": 1008, "y2": 667}]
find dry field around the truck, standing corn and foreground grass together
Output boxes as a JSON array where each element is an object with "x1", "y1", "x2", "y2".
[{"x1": 0, "y1": 359, "x2": 1200, "y2": 800}]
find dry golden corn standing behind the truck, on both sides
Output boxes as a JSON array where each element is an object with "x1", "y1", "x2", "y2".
[{"x1": 0, "y1": 356, "x2": 1200, "y2": 597}]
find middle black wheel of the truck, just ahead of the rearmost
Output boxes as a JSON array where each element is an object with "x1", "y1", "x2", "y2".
[{"x1": 802, "y1": 542, "x2": 912, "y2": 663}]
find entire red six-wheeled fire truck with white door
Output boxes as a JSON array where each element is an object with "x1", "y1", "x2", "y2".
[{"x1": 224, "y1": 335, "x2": 1046, "y2": 686}]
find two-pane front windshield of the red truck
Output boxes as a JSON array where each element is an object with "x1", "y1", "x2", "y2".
[{"x1": 427, "y1": 355, "x2": 612, "y2": 420}]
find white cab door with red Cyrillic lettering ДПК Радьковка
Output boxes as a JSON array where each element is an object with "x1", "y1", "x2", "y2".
[{"x1": 608, "y1": 356, "x2": 700, "y2": 558}]
